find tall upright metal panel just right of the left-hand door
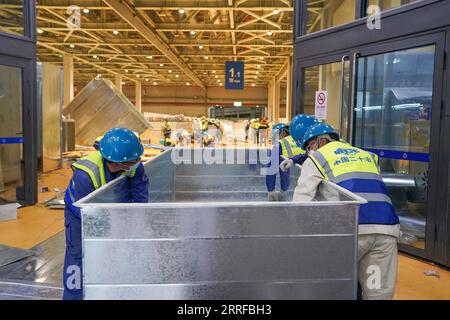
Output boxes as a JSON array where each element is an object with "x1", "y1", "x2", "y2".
[{"x1": 38, "y1": 62, "x2": 62, "y2": 172}]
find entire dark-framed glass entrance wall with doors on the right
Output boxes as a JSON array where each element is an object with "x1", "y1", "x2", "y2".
[{"x1": 292, "y1": 0, "x2": 450, "y2": 266}]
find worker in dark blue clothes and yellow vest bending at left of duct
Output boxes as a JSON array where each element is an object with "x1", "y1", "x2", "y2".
[{"x1": 63, "y1": 128, "x2": 149, "y2": 300}]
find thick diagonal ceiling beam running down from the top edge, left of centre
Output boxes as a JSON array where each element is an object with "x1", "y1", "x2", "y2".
[{"x1": 103, "y1": 0, "x2": 206, "y2": 90}]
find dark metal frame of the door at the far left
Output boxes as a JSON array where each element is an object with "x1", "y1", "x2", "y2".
[{"x1": 0, "y1": 55, "x2": 37, "y2": 204}]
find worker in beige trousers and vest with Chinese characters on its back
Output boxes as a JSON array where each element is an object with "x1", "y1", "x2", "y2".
[{"x1": 294, "y1": 123, "x2": 400, "y2": 300}]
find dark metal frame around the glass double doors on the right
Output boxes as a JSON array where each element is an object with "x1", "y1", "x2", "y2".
[{"x1": 292, "y1": 29, "x2": 450, "y2": 261}]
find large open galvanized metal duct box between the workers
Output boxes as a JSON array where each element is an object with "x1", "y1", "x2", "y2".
[{"x1": 77, "y1": 150, "x2": 365, "y2": 299}]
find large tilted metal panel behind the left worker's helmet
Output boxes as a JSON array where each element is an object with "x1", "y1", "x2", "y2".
[{"x1": 63, "y1": 79, "x2": 151, "y2": 146}]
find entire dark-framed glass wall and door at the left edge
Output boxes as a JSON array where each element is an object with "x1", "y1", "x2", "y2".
[{"x1": 0, "y1": 0, "x2": 37, "y2": 206}]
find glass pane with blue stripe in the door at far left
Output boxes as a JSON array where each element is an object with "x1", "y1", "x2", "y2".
[{"x1": 0, "y1": 65, "x2": 24, "y2": 205}]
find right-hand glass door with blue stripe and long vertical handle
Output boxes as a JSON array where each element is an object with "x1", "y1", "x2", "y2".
[{"x1": 350, "y1": 34, "x2": 444, "y2": 258}]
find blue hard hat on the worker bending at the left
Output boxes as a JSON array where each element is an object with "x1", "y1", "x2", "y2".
[{"x1": 100, "y1": 128, "x2": 144, "y2": 162}]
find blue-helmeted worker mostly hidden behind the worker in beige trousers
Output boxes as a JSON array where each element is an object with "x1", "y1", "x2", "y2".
[{"x1": 280, "y1": 114, "x2": 319, "y2": 172}]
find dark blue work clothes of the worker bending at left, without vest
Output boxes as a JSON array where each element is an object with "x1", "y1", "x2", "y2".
[{"x1": 63, "y1": 160, "x2": 149, "y2": 300}]
